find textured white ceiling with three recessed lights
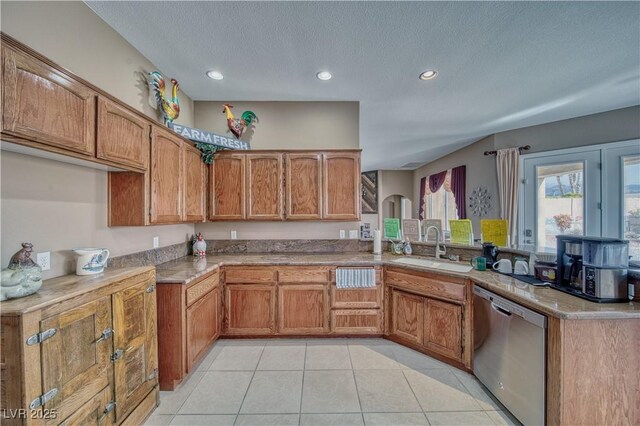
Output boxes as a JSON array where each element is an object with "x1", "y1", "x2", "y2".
[{"x1": 87, "y1": 1, "x2": 640, "y2": 170}]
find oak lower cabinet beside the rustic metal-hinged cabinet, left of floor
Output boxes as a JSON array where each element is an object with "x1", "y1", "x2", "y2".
[{"x1": 157, "y1": 270, "x2": 222, "y2": 390}]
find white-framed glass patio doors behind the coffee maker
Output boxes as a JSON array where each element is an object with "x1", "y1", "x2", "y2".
[{"x1": 518, "y1": 140, "x2": 640, "y2": 260}]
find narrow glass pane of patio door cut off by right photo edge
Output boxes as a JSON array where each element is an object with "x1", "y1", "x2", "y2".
[{"x1": 622, "y1": 155, "x2": 640, "y2": 260}]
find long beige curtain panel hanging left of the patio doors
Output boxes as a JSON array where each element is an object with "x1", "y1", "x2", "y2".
[{"x1": 496, "y1": 148, "x2": 520, "y2": 243}]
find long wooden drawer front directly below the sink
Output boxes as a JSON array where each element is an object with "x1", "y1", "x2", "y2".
[{"x1": 385, "y1": 271, "x2": 466, "y2": 301}]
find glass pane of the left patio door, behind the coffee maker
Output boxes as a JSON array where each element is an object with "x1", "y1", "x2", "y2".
[{"x1": 536, "y1": 162, "x2": 584, "y2": 248}]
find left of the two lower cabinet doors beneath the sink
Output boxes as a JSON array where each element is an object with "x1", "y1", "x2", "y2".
[{"x1": 391, "y1": 289, "x2": 424, "y2": 345}]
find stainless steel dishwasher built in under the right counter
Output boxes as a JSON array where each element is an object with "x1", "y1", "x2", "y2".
[{"x1": 473, "y1": 285, "x2": 547, "y2": 425}]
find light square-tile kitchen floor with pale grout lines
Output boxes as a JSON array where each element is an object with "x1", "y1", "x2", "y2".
[{"x1": 146, "y1": 338, "x2": 518, "y2": 426}]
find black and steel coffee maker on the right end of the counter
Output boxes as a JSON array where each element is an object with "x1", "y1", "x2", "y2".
[{"x1": 552, "y1": 235, "x2": 629, "y2": 303}]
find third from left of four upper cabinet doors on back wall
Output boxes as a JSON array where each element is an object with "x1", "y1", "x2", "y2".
[{"x1": 285, "y1": 153, "x2": 322, "y2": 220}]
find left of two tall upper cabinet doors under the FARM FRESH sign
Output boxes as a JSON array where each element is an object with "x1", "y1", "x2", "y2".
[{"x1": 151, "y1": 126, "x2": 183, "y2": 223}]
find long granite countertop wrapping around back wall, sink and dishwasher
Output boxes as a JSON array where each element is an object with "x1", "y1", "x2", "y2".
[{"x1": 156, "y1": 252, "x2": 640, "y2": 319}]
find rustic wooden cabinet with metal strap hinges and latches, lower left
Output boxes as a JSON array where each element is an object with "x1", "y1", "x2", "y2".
[{"x1": 0, "y1": 267, "x2": 158, "y2": 425}]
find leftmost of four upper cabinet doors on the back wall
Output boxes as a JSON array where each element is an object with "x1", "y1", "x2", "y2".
[{"x1": 209, "y1": 154, "x2": 246, "y2": 220}]
